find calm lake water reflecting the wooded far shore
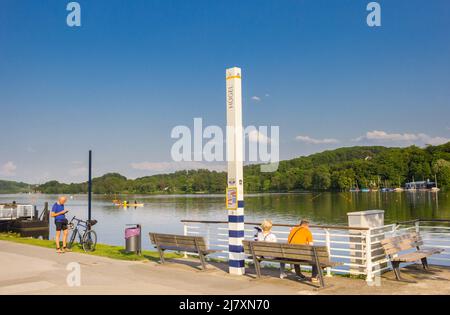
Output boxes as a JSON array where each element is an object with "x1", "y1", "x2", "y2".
[{"x1": 0, "y1": 192, "x2": 450, "y2": 248}]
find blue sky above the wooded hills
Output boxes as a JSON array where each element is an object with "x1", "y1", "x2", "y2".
[{"x1": 0, "y1": 0, "x2": 450, "y2": 183}]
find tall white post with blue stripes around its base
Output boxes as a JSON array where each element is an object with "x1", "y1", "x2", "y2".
[{"x1": 226, "y1": 67, "x2": 245, "y2": 275}]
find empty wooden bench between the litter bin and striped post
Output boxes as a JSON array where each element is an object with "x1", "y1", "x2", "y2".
[{"x1": 149, "y1": 233, "x2": 216, "y2": 270}]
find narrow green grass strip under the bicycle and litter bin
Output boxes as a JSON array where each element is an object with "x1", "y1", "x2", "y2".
[{"x1": 0, "y1": 233, "x2": 183, "y2": 261}]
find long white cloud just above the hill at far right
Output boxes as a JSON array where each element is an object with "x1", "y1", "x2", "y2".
[{"x1": 354, "y1": 130, "x2": 450, "y2": 145}]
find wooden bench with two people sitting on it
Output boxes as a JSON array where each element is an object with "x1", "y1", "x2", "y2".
[{"x1": 243, "y1": 241, "x2": 340, "y2": 288}]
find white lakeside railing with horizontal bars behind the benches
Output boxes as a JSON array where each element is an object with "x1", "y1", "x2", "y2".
[{"x1": 181, "y1": 220, "x2": 450, "y2": 281}]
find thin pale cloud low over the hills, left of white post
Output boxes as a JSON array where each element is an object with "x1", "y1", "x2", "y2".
[{"x1": 131, "y1": 161, "x2": 226, "y2": 172}]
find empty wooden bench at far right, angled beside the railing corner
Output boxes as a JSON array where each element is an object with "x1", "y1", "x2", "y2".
[{"x1": 381, "y1": 233, "x2": 444, "y2": 280}]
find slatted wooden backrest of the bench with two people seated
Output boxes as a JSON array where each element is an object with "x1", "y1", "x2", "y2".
[{"x1": 243, "y1": 241, "x2": 330, "y2": 264}]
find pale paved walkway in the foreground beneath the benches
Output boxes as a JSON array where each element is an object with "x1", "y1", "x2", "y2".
[{"x1": 0, "y1": 241, "x2": 450, "y2": 295}]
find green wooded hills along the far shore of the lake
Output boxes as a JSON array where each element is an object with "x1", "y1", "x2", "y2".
[{"x1": 4, "y1": 142, "x2": 450, "y2": 194}]
